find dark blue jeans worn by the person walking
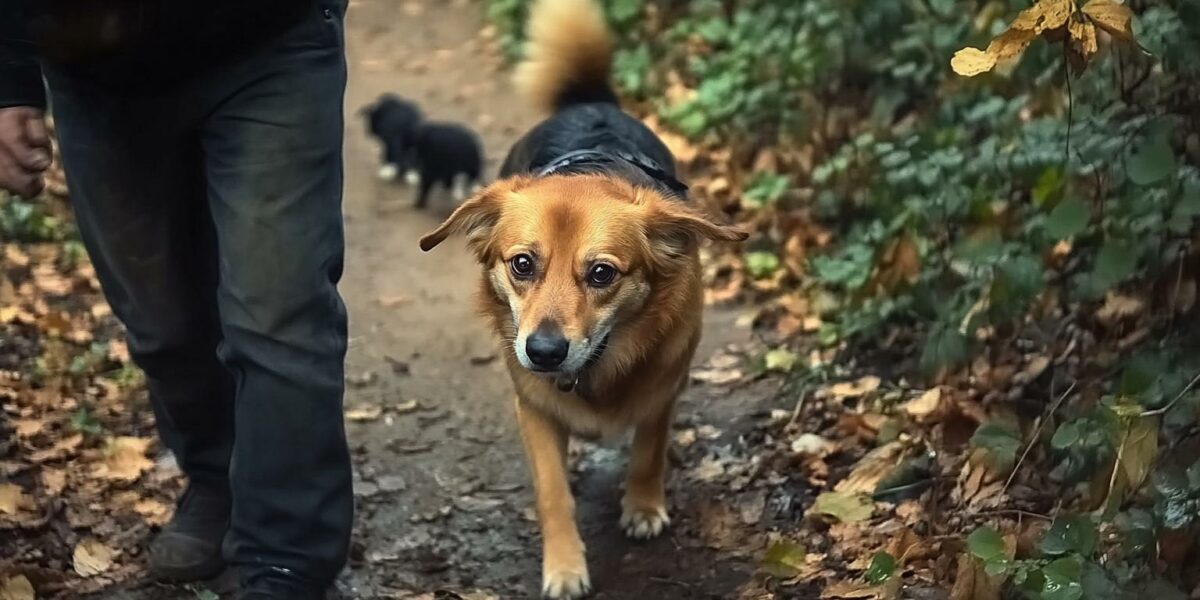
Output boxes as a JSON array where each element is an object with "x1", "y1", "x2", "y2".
[{"x1": 47, "y1": 0, "x2": 353, "y2": 584}]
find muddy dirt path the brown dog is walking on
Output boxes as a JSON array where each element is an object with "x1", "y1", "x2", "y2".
[{"x1": 343, "y1": 0, "x2": 777, "y2": 599}]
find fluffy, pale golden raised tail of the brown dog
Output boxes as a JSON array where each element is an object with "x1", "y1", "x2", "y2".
[{"x1": 515, "y1": 0, "x2": 617, "y2": 113}]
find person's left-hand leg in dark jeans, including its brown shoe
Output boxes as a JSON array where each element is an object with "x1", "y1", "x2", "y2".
[{"x1": 49, "y1": 72, "x2": 233, "y2": 580}]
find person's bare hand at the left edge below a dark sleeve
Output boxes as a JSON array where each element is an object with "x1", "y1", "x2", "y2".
[{"x1": 0, "y1": 107, "x2": 50, "y2": 198}]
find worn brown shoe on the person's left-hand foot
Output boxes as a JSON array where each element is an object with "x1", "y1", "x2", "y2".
[{"x1": 150, "y1": 484, "x2": 232, "y2": 582}]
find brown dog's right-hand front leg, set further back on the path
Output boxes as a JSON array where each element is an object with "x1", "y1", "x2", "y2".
[{"x1": 620, "y1": 402, "x2": 674, "y2": 540}]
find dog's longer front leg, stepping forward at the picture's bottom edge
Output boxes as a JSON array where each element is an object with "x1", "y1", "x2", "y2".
[{"x1": 516, "y1": 398, "x2": 592, "y2": 600}]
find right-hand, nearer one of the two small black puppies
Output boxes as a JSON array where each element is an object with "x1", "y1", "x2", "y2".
[{"x1": 406, "y1": 121, "x2": 484, "y2": 209}]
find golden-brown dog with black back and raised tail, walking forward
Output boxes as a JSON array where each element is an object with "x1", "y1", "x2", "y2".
[{"x1": 421, "y1": 0, "x2": 746, "y2": 599}]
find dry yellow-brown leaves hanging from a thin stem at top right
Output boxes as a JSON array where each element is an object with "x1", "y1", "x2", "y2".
[{"x1": 950, "y1": 0, "x2": 1134, "y2": 77}]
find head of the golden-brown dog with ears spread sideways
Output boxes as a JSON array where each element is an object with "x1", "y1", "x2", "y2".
[{"x1": 421, "y1": 175, "x2": 748, "y2": 383}]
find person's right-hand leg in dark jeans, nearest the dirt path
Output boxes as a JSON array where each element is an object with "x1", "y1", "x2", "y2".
[{"x1": 196, "y1": 2, "x2": 353, "y2": 590}]
